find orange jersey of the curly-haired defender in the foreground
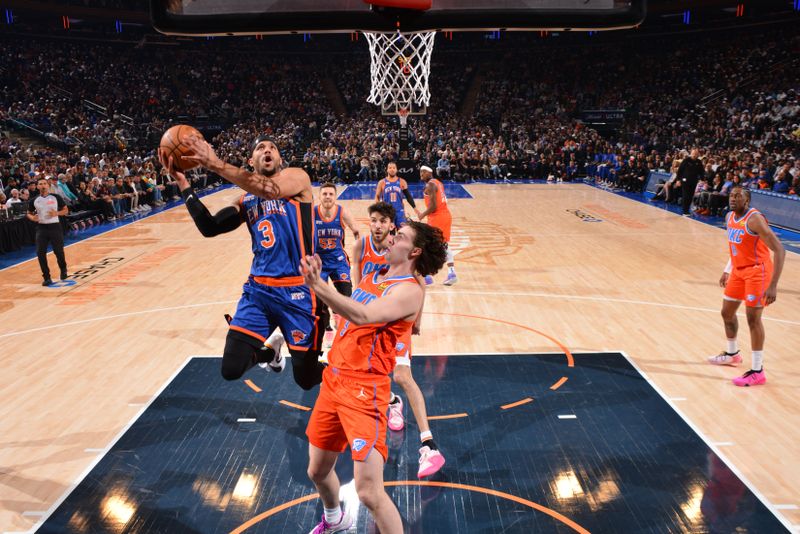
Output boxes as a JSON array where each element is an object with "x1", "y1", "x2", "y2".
[{"x1": 328, "y1": 270, "x2": 417, "y2": 375}]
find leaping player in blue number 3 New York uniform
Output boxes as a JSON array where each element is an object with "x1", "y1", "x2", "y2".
[{"x1": 160, "y1": 135, "x2": 328, "y2": 390}]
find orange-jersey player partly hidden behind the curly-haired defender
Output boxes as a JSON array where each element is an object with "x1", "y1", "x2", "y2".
[{"x1": 353, "y1": 202, "x2": 445, "y2": 478}]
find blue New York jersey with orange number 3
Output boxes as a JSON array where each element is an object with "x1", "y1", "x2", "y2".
[{"x1": 240, "y1": 197, "x2": 314, "y2": 278}]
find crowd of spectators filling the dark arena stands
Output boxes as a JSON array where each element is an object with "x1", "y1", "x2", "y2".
[{"x1": 0, "y1": 21, "x2": 800, "y2": 232}]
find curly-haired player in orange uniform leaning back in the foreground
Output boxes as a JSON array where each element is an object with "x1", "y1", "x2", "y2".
[{"x1": 300, "y1": 222, "x2": 447, "y2": 534}]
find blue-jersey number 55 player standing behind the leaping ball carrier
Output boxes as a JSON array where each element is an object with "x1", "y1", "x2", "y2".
[{"x1": 314, "y1": 182, "x2": 360, "y2": 345}]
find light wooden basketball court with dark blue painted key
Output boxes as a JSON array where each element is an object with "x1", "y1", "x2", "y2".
[{"x1": 0, "y1": 184, "x2": 800, "y2": 532}]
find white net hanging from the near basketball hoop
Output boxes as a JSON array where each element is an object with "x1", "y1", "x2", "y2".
[{"x1": 365, "y1": 31, "x2": 436, "y2": 114}]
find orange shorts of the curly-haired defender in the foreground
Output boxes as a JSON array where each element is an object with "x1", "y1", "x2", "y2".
[{"x1": 306, "y1": 366, "x2": 391, "y2": 462}]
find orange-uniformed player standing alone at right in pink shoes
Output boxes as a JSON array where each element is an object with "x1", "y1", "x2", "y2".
[{"x1": 708, "y1": 187, "x2": 786, "y2": 386}]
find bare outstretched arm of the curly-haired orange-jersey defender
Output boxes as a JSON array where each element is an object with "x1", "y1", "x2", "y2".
[{"x1": 300, "y1": 255, "x2": 422, "y2": 325}]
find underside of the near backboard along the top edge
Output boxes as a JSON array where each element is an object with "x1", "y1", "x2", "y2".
[{"x1": 150, "y1": 0, "x2": 646, "y2": 35}]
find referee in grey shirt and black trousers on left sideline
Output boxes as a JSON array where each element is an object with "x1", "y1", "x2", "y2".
[{"x1": 28, "y1": 178, "x2": 69, "y2": 286}]
